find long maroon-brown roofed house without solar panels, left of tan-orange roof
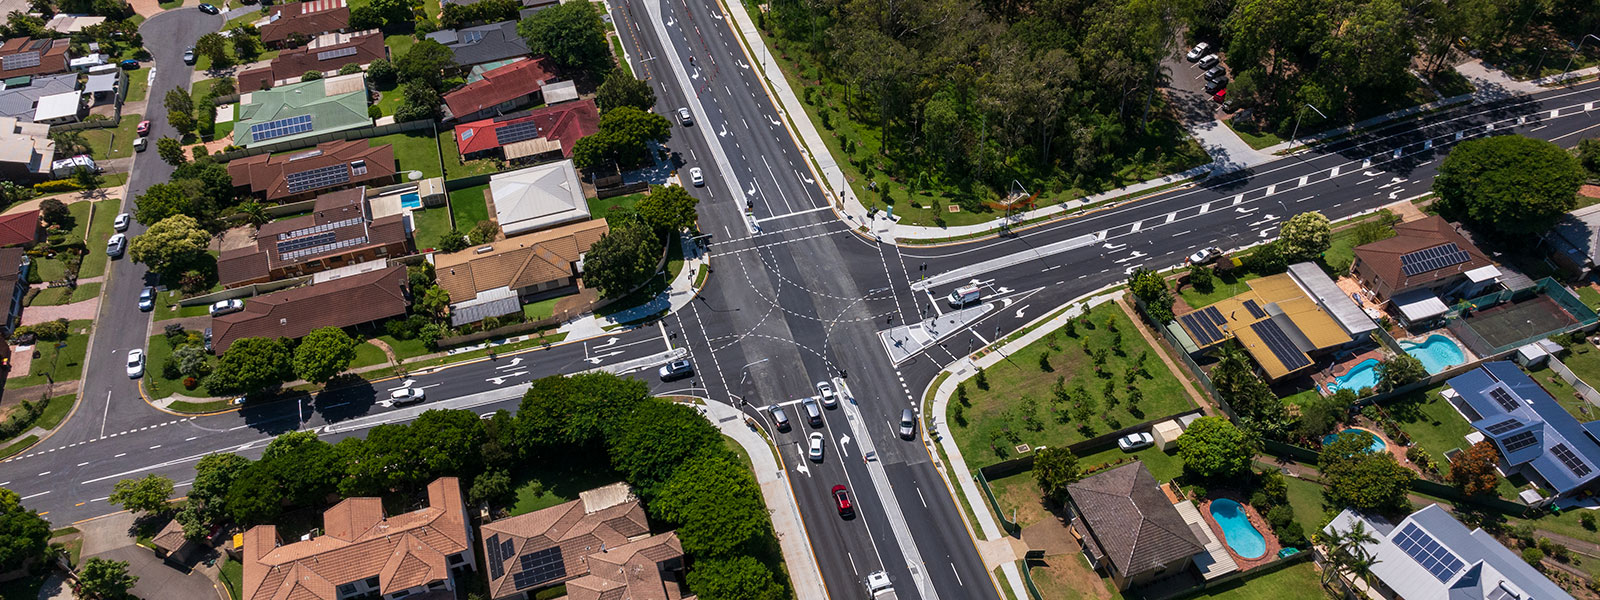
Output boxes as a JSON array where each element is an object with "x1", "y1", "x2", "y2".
[{"x1": 211, "y1": 264, "x2": 411, "y2": 355}]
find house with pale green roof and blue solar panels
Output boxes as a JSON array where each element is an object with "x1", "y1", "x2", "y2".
[{"x1": 234, "y1": 74, "x2": 373, "y2": 147}]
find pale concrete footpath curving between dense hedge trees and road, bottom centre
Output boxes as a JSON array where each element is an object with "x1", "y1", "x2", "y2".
[{"x1": 699, "y1": 402, "x2": 827, "y2": 600}]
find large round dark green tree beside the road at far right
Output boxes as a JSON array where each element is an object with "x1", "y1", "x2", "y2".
[{"x1": 1434, "y1": 136, "x2": 1584, "y2": 237}]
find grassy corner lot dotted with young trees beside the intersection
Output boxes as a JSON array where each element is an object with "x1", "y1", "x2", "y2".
[{"x1": 947, "y1": 304, "x2": 1194, "y2": 469}]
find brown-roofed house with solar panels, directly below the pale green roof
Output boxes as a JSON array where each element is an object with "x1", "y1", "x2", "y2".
[{"x1": 227, "y1": 139, "x2": 398, "y2": 202}]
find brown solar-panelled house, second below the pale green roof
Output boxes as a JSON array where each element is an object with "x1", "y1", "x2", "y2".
[{"x1": 216, "y1": 187, "x2": 416, "y2": 288}]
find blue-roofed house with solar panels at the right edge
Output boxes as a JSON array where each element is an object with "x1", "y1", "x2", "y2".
[{"x1": 1446, "y1": 360, "x2": 1600, "y2": 498}]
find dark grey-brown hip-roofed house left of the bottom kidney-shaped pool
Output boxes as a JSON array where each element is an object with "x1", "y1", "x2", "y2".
[{"x1": 1067, "y1": 461, "x2": 1205, "y2": 590}]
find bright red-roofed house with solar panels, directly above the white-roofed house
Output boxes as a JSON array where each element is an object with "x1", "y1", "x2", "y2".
[{"x1": 456, "y1": 99, "x2": 600, "y2": 162}]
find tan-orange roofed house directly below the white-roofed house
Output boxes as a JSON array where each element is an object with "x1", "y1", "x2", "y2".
[{"x1": 430, "y1": 219, "x2": 610, "y2": 325}]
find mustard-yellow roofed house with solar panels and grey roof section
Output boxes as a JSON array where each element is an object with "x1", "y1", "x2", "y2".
[{"x1": 1178, "y1": 262, "x2": 1378, "y2": 381}]
